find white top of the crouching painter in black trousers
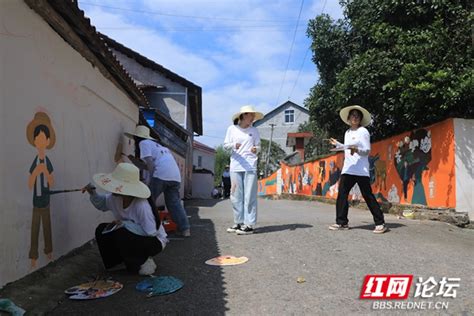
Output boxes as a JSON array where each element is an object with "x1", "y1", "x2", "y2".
[{"x1": 105, "y1": 193, "x2": 168, "y2": 249}]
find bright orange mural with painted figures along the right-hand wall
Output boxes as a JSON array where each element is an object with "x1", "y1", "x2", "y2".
[{"x1": 259, "y1": 119, "x2": 455, "y2": 207}]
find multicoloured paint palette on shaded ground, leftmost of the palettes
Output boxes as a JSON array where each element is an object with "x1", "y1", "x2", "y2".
[{"x1": 64, "y1": 280, "x2": 123, "y2": 300}]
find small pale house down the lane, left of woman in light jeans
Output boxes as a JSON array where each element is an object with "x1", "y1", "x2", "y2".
[{"x1": 193, "y1": 141, "x2": 216, "y2": 199}]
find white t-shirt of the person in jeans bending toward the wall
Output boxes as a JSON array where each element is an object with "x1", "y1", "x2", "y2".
[{"x1": 140, "y1": 139, "x2": 181, "y2": 182}]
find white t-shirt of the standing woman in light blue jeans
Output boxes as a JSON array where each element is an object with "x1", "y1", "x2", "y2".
[{"x1": 224, "y1": 125, "x2": 260, "y2": 172}]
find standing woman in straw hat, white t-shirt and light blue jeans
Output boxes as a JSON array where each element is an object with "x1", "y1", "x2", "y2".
[{"x1": 224, "y1": 105, "x2": 263, "y2": 235}]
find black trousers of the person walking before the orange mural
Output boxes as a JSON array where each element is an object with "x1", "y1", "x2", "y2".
[{"x1": 336, "y1": 174, "x2": 385, "y2": 225}]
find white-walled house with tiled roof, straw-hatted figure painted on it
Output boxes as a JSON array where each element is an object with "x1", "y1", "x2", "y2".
[{"x1": 0, "y1": 0, "x2": 148, "y2": 287}]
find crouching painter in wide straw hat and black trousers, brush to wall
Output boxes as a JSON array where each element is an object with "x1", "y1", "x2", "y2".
[{"x1": 83, "y1": 163, "x2": 168, "y2": 275}]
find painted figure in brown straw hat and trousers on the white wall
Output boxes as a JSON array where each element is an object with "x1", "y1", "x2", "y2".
[{"x1": 26, "y1": 112, "x2": 56, "y2": 268}]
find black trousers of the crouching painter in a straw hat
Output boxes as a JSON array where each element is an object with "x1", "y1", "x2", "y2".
[{"x1": 95, "y1": 223, "x2": 162, "y2": 273}]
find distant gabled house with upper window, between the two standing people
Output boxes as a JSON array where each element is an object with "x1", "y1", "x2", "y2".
[{"x1": 254, "y1": 101, "x2": 309, "y2": 154}]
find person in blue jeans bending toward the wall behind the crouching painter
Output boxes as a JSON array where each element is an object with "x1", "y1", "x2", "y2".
[{"x1": 125, "y1": 125, "x2": 191, "y2": 237}]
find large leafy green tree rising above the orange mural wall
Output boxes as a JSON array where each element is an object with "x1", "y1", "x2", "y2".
[{"x1": 305, "y1": 0, "x2": 474, "y2": 140}]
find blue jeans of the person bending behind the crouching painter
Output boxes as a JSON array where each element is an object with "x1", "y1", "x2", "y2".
[{"x1": 150, "y1": 177, "x2": 189, "y2": 232}]
